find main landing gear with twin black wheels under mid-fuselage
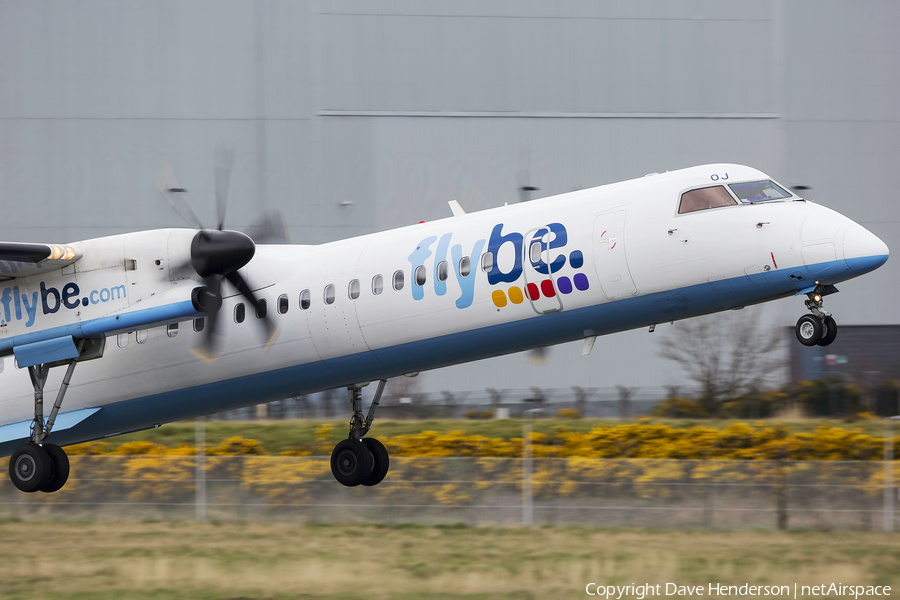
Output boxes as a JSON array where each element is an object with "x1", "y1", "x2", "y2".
[{"x1": 331, "y1": 379, "x2": 390, "y2": 486}]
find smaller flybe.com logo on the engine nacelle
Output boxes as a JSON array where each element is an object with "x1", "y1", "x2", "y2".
[{"x1": 0, "y1": 281, "x2": 125, "y2": 328}]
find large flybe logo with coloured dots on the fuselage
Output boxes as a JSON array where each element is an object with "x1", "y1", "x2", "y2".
[{"x1": 409, "y1": 223, "x2": 590, "y2": 308}]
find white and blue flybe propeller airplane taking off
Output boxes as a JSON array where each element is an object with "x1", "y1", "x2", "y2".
[{"x1": 0, "y1": 164, "x2": 888, "y2": 492}]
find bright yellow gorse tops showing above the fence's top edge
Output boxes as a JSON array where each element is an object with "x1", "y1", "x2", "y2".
[{"x1": 68, "y1": 422, "x2": 900, "y2": 460}]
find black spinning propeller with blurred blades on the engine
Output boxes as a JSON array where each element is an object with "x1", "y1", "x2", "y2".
[{"x1": 157, "y1": 144, "x2": 287, "y2": 362}]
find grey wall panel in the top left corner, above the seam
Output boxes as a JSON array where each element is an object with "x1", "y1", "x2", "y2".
[{"x1": 0, "y1": 0, "x2": 309, "y2": 120}]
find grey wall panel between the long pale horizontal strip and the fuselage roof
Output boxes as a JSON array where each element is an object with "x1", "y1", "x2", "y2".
[{"x1": 323, "y1": 117, "x2": 777, "y2": 234}]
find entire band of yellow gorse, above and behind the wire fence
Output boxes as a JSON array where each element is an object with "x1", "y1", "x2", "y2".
[{"x1": 37, "y1": 421, "x2": 900, "y2": 510}]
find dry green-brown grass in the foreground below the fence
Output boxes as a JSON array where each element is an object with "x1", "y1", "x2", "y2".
[{"x1": 0, "y1": 522, "x2": 900, "y2": 600}]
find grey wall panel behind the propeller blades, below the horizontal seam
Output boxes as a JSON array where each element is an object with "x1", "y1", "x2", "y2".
[{"x1": 0, "y1": 119, "x2": 310, "y2": 241}]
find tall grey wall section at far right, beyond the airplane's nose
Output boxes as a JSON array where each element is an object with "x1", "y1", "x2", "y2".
[{"x1": 783, "y1": 0, "x2": 900, "y2": 325}]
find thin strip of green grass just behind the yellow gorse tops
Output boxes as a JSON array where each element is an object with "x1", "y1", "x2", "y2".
[{"x1": 93, "y1": 414, "x2": 884, "y2": 454}]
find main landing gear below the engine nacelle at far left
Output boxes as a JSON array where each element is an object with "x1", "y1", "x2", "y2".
[{"x1": 9, "y1": 342, "x2": 84, "y2": 493}]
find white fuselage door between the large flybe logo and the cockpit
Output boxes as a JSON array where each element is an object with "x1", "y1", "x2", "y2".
[{"x1": 593, "y1": 210, "x2": 637, "y2": 300}]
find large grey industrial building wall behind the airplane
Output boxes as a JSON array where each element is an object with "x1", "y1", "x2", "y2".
[{"x1": 0, "y1": 0, "x2": 900, "y2": 390}]
